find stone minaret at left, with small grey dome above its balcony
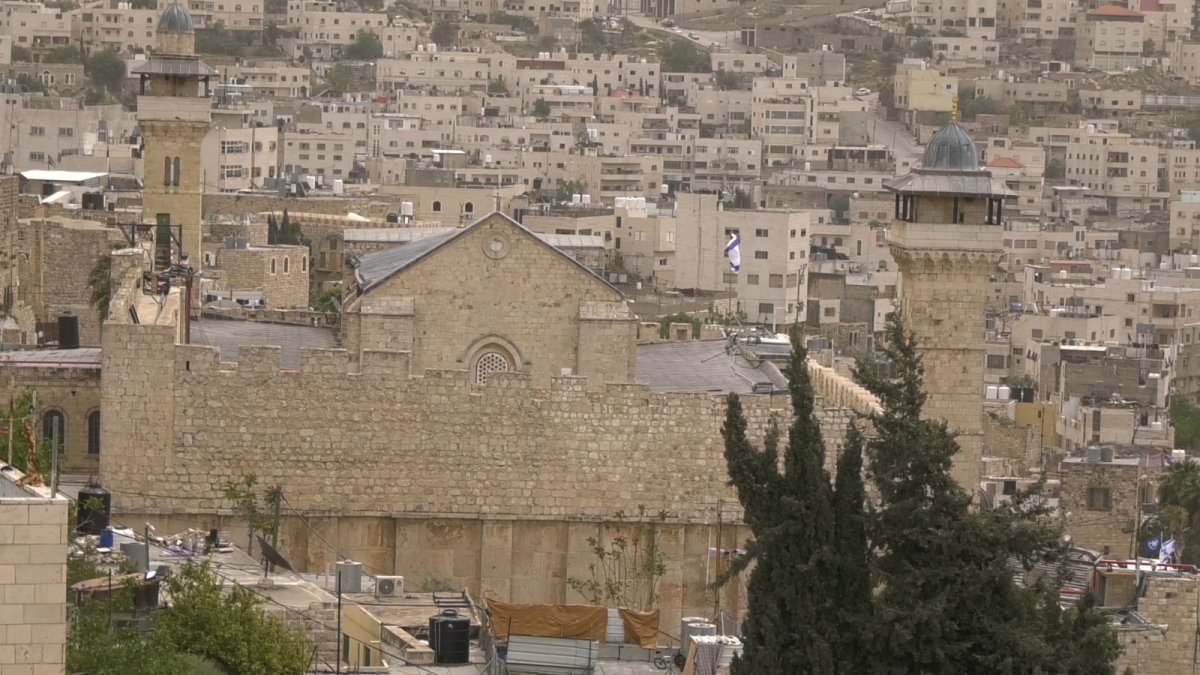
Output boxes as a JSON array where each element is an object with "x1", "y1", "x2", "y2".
[{"x1": 133, "y1": 0, "x2": 217, "y2": 270}]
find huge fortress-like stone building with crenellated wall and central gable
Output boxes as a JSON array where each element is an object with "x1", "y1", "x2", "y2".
[{"x1": 101, "y1": 208, "x2": 877, "y2": 626}]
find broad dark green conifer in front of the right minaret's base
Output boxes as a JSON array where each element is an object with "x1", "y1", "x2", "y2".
[{"x1": 856, "y1": 315, "x2": 1118, "y2": 675}]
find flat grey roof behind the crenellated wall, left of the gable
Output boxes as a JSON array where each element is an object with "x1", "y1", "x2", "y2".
[{"x1": 192, "y1": 318, "x2": 337, "y2": 369}]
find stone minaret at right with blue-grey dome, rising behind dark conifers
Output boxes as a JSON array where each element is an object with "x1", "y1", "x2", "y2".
[{"x1": 884, "y1": 121, "x2": 1010, "y2": 494}]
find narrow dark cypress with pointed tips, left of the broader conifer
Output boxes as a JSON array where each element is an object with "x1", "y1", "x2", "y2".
[{"x1": 721, "y1": 335, "x2": 857, "y2": 675}]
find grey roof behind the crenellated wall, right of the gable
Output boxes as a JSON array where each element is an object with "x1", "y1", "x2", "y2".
[{"x1": 636, "y1": 340, "x2": 787, "y2": 394}]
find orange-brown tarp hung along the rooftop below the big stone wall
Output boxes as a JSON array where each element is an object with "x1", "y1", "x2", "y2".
[{"x1": 487, "y1": 599, "x2": 659, "y2": 649}]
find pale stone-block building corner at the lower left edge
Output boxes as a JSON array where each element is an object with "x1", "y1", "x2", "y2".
[{"x1": 0, "y1": 470, "x2": 67, "y2": 675}]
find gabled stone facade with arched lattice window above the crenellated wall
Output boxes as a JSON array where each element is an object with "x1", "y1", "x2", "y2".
[{"x1": 342, "y1": 214, "x2": 637, "y2": 386}]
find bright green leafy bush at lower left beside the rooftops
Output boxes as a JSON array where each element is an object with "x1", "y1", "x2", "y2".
[{"x1": 154, "y1": 560, "x2": 308, "y2": 675}]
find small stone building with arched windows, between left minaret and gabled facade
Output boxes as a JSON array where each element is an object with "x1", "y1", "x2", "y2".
[{"x1": 214, "y1": 245, "x2": 308, "y2": 309}]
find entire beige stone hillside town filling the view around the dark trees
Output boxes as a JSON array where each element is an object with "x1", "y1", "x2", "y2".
[{"x1": 7, "y1": 0, "x2": 1200, "y2": 675}]
